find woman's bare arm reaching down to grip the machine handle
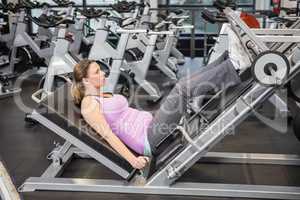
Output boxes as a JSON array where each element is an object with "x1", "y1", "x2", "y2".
[{"x1": 81, "y1": 97, "x2": 148, "y2": 169}]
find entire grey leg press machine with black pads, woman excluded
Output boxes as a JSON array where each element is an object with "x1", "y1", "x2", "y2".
[{"x1": 19, "y1": 8, "x2": 300, "y2": 200}]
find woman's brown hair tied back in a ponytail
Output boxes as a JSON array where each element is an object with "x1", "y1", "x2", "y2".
[{"x1": 71, "y1": 59, "x2": 95, "y2": 105}]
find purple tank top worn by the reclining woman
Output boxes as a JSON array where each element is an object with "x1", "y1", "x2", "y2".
[{"x1": 95, "y1": 94, "x2": 153, "y2": 154}]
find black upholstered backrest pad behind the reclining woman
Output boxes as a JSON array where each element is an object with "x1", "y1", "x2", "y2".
[{"x1": 38, "y1": 84, "x2": 136, "y2": 179}]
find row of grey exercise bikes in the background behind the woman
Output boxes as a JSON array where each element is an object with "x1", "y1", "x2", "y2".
[{"x1": 0, "y1": 0, "x2": 193, "y2": 102}]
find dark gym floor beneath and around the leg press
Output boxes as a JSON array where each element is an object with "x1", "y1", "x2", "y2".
[{"x1": 0, "y1": 60, "x2": 300, "y2": 200}]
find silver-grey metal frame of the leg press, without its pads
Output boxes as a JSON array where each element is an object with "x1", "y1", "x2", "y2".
[{"x1": 19, "y1": 8, "x2": 300, "y2": 200}]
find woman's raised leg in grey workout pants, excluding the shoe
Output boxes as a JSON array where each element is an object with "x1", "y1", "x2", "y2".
[{"x1": 148, "y1": 59, "x2": 240, "y2": 152}]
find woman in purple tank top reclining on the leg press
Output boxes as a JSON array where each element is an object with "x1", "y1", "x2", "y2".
[{"x1": 72, "y1": 22, "x2": 250, "y2": 169}]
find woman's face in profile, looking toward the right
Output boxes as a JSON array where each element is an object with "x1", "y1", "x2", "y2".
[{"x1": 87, "y1": 62, "x2": 105, "y2": 89}]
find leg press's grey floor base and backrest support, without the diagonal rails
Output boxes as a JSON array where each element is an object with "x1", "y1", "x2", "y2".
[{"x1": 19, "y1": 112, "x2": 300, "y2": 199}]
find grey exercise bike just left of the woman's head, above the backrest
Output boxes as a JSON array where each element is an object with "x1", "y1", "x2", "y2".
[{"x1": 32, "y1": 1, "x2": 78, "y2": 103}]
